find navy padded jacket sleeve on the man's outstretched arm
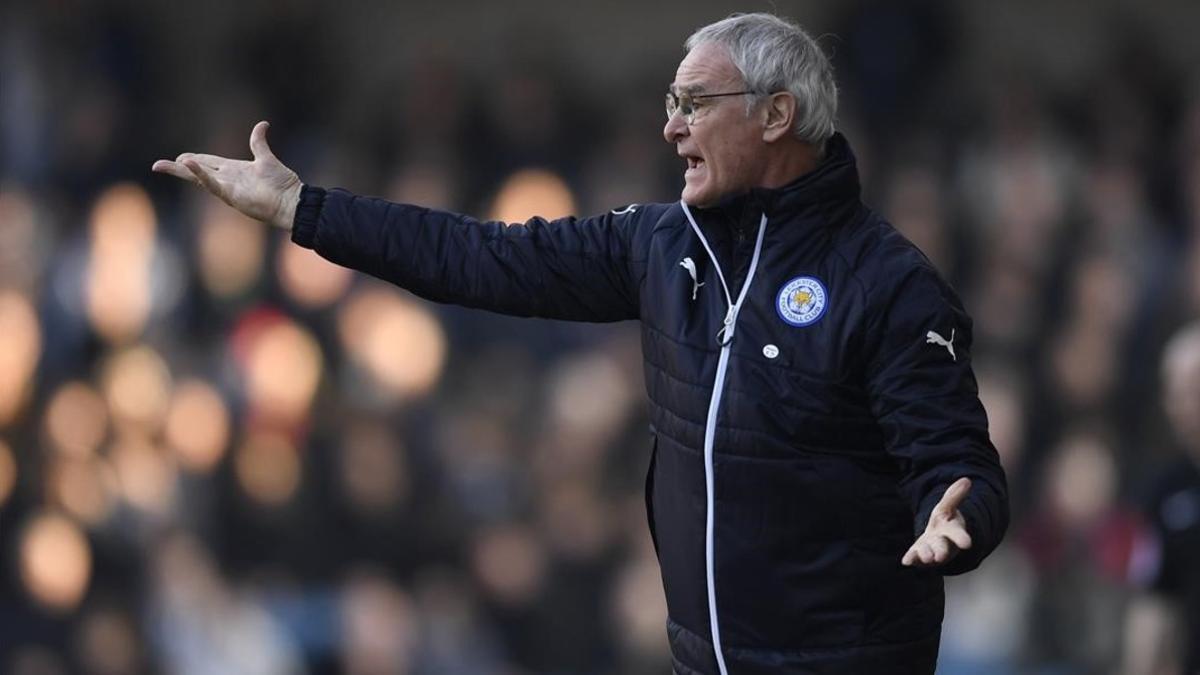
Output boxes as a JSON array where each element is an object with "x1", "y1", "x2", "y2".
[{"x1": 292, "y1": 186, "x2": 640, "y2": 322}]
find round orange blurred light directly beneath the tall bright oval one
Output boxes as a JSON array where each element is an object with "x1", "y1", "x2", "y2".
[{"x1": 101, "y1": 345, "x2": 170, "y2": 434}]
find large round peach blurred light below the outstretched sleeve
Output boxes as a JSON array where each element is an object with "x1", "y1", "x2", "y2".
[{"x1": 338, "y1": 286, "x2": 446, "y2": 396}]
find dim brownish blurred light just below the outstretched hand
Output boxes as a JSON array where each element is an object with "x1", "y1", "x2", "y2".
[{"x1": 196, "y1": 199, "x2": 266, "y2": 298}]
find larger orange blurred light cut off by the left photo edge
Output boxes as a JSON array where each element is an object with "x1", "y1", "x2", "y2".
[{"x1": 0, "y1": 291, "x2": 42, "y2": 428}]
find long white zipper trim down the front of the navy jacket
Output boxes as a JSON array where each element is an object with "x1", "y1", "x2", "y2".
[{"x1": 679, "y1": 201, "x2": 767, "y2": 675}]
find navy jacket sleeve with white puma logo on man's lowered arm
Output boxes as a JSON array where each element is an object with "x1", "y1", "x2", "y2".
[{"x1": 865, "y1": 258, "x2": 1008, "y2": 574}]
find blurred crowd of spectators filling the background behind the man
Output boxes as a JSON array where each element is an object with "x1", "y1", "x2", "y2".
[{"x1": 7, "y1": 0, "x2": 1200, "y2": 675}]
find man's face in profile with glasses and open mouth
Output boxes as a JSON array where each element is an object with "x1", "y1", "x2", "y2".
[{"x1": 662, "y1": 43, "x2": 764, "y2": 207}]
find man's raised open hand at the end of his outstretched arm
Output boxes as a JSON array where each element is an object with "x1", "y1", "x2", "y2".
[{"x1": 150, "y1": 121, "x2": 302, "y2": 229}]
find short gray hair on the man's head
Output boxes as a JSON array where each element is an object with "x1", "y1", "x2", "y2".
[{"x1": 684, "y1": 12, "x2": 838, "y2": 148}]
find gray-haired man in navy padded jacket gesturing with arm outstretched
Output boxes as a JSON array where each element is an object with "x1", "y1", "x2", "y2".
[{"x1": 154, "y1": 14, "x2": 1008, "y2": 675}]
